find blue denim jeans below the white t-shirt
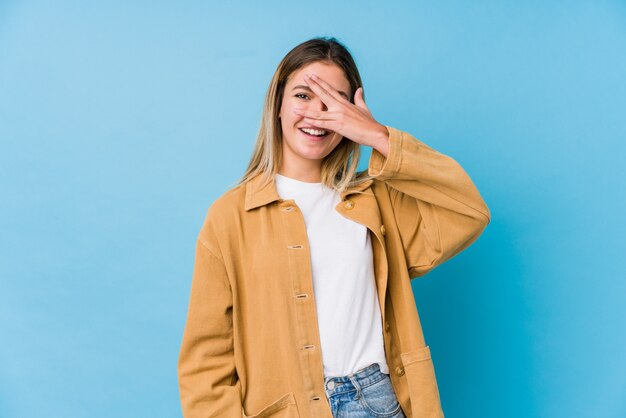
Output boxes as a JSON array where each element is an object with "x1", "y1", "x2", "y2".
[{"x1": 324, "y1": 363, "x2": 406, "y2": 418}]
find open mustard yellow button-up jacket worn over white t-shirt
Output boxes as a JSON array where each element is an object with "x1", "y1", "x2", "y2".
[{"x1": 178, "y1": 126, "x2": 491, "y2": 418}]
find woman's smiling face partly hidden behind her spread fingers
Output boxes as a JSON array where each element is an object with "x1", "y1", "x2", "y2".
[{"x1": 279, "y1": 62, "x2": 352, "y2": 168}]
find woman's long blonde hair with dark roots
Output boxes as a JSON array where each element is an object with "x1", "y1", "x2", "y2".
[{"x1": 236, "y1": 37, "x2": 371, "y2": 192}]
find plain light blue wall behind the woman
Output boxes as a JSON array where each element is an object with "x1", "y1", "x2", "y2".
[{"x1": 0, "y1": 0, "x2": 626, "y2": 418}]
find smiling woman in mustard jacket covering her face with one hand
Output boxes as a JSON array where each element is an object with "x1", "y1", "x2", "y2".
[{"x1": 178, "y1": 38, "x2": 490, "y2": 418}]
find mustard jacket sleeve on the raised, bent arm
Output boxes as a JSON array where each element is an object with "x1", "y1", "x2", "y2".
[{"x1": 368, "y1": 126, "x2": 491, "y2": 279}]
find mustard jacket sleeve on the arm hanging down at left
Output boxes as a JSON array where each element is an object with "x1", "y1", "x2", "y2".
[{"x1": 178, "y1": 230, "x2": 243, "y2": 418}]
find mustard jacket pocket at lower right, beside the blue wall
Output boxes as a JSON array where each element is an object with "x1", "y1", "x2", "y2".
[{"x1": 400, "y1": 346, "x2": 443, "y2": 418}]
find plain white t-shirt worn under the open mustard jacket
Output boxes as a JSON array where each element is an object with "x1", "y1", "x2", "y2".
[{"x1": 276, "y1": 174, "x2": 389, "y2": 377}]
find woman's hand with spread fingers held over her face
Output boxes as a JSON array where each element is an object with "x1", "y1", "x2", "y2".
[{"x1": 294, "y1": 74, "x2": 389, "y2": 148}]
